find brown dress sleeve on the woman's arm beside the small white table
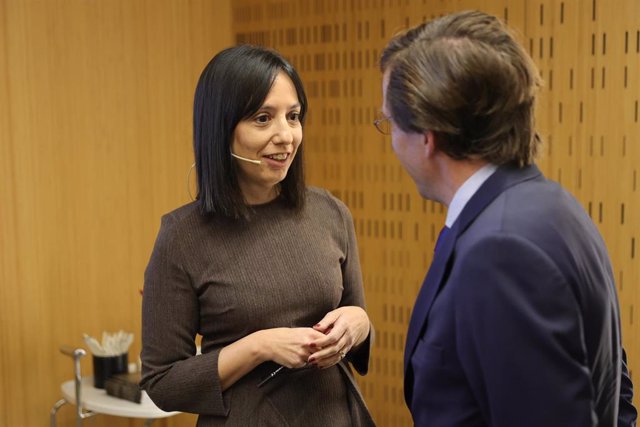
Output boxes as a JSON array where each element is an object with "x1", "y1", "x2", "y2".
[{"x1": 140, "y1": 216, "x2": 229, "y2": 416}]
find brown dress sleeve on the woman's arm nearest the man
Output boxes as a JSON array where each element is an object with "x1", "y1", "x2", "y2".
[{"x1": 338, "y1": 202, "x2": 374, "y2": 375}]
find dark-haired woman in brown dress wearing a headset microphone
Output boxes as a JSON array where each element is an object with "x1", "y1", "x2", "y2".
[{"x1": 141, "y1": 46, "x2": 373, "y2": 426}]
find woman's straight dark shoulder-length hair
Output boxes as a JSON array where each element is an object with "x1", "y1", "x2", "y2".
[{"x1": 193, "y1": 45, "x2": 307, "y2": 219}]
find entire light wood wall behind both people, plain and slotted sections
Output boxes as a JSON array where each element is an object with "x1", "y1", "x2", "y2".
[{"x1": 0, "y1": 0, "x2": 640, "y2": 426}]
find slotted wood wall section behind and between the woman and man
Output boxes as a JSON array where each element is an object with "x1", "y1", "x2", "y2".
[{"x1": 233, "y1": 0, "x2": 640, "y2": 426}]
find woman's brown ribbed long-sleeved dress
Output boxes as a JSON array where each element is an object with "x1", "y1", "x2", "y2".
[{"x1": 142, "y1": 188, "x2": 373, "y2": 427}]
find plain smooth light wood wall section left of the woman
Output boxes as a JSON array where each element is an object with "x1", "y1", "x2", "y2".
[{"x1": 0, "y1": 0, "x2": 232, "y2": 427}]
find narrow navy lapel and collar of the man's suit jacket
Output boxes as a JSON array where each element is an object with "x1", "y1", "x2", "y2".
[{"x1": 404, "y1": 166, "x2": 541, "y2": 403}]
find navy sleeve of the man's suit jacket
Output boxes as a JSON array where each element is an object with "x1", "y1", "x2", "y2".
[{"x1": 447, "y1": 236, "x2": 597, "y2": 427}]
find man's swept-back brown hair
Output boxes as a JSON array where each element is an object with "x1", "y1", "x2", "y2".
[{"x1": 380, "y1": 11, "x2": 541, "y2": 166}]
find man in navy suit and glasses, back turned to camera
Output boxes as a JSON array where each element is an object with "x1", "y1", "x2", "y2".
[{"x1": 376, "y1": 12, "x2": 636, "y2": 427}]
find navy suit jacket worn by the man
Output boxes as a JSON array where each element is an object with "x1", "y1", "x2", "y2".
[{"x1": 404, "y1": 166, "x2": 636, "y2": 427}]
